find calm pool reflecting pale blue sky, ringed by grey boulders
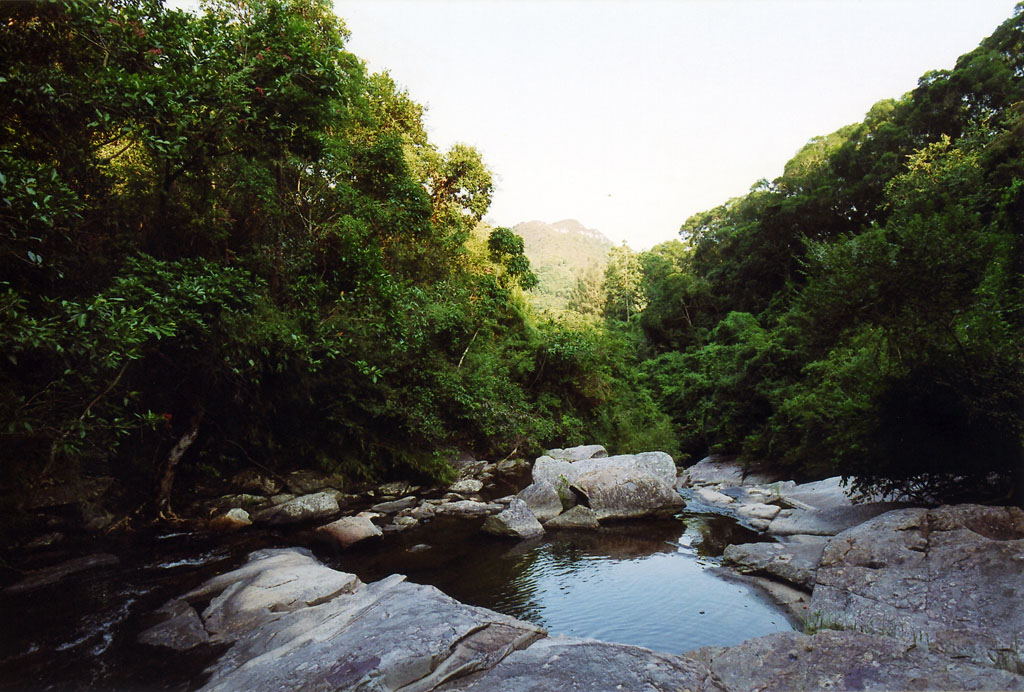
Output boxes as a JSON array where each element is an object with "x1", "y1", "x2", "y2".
[{"x1": 327, "y1": 516, "x2": 792, "y2": 653}]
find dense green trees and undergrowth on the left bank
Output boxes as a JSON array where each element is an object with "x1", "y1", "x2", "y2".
[{"x1": 0, "y1": 0, "x2": 671, "y2": 514}]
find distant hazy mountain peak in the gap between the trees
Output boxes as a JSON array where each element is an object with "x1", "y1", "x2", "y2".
[{"x1": 513, "y1": 219, "x2": 612, "y2": 312}]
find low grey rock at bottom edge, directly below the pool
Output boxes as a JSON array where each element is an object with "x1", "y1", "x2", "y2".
[{"x1": 436, "y1": 637, "x2": 726, "y2": 692}]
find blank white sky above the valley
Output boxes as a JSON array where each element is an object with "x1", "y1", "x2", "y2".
[{"x1": 335, "y1": 0, "x2": 1015, "y2": 250}]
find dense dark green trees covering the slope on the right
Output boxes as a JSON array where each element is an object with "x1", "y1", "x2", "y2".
[{"x1": 639, "y1": 4, "x2": 1024, "y2": 502}]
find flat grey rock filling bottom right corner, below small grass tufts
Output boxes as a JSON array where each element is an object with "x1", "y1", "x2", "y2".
[{"x1": 688, "y1": 632, "x2": 1024, "y2": 692}]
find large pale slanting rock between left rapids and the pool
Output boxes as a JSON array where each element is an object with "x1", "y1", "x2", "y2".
[{"x1": 142, "y1": 549, "x2": 544, "y2": 692}]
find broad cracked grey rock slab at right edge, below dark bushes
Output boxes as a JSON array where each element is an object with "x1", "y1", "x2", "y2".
[{"x1": 811, "y1": 505, "x2": 1024, "y2": 674}]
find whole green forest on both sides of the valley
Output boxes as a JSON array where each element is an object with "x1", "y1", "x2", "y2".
[{"x1": 0, "y1": 0, "x2": 1024, "y2": 528}]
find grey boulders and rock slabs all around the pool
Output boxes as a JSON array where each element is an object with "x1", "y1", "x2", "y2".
[{"x1": 6, "y1": 447, "x2": 1024, "y2": 691}]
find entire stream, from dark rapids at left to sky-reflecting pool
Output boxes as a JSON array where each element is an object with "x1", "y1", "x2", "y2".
[{"x1": 0, "y1": 505, "x2": 793, "y2": 692}]
